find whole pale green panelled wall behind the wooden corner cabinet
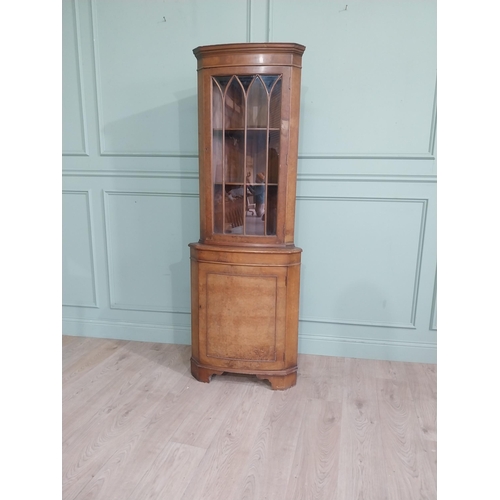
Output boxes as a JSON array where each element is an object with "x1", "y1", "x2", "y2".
[{"x1": 63, "y1": 0, "x2": 437, "y2": 362}]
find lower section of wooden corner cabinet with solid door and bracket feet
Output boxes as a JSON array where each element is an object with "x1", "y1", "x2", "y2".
[{"x1": 190, "y1": 244, "x2": 301, "y2": 389}]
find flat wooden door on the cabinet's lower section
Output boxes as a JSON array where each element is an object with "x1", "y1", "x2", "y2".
[{"x1": 198, "y1": 263, "x2": 287, "y2": 370}]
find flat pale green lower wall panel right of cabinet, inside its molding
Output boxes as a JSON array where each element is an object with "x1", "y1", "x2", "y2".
[{"x1": 297, "y1": 196, "x2": 427, "y2": 328}]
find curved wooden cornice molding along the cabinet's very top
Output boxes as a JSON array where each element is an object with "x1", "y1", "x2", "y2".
[{"x1": 193, "y1": 42, "x2": 306, "y2": 70}]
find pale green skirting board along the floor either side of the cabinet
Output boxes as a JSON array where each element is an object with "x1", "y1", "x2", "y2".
[{"x1": 62, "y1": 318, "x2": 437, "y2": 364}]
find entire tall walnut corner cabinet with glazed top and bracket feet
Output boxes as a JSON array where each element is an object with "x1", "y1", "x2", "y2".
[{"x1": 189, "y1": 43, "x2": 305, "y2": 389}]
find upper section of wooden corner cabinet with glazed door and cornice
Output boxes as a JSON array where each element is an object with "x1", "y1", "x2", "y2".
[{"x1": 194, "y1": 43, "x2": 304, "y2": 246}]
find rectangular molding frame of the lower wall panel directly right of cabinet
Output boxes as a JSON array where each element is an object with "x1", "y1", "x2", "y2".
[{"x1": 297, "y1": 195, "x2": 428, "y2": 329}]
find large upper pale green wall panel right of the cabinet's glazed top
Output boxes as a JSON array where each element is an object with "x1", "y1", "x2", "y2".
[{"x1": 271, "y1": 0, "x2": 436, "y2": 157}]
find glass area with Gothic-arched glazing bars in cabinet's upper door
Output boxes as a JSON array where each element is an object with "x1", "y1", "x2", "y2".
[{"x1": 209, "y1": 72, "x2": 286, "y2": 240}]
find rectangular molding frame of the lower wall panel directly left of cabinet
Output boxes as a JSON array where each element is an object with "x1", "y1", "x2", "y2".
[{"x1": 103, "y1": 190, "x2": 199, "y2": 315}]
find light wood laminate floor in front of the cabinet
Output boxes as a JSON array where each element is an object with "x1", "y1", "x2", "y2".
[{"x1": 62, "y1": 336, "x2": 436, "y2": 500}]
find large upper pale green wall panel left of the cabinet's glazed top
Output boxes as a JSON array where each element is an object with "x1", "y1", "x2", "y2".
[{"x1": 92, "y1": 0, "x2": 247, "y2": 156}]
